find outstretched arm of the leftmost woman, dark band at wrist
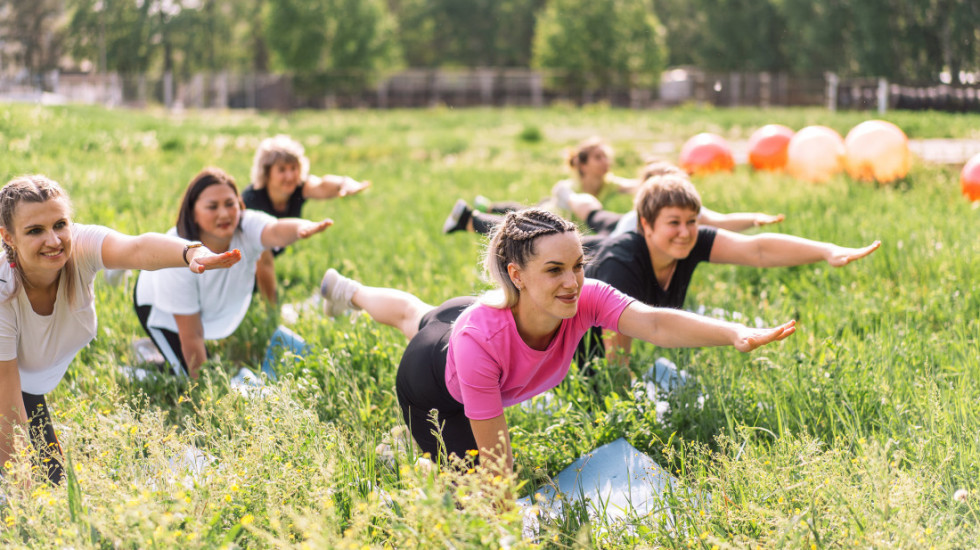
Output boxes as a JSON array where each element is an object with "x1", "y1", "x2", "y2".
[{"x1": 102, "y1": 231, "x2": 242, "y2": 273}]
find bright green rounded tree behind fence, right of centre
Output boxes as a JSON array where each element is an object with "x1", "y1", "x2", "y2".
[{"x1": 533, "y1": 0, "x2": 667, "y2": 90}]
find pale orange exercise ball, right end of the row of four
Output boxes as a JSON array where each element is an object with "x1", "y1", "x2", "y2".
[{"x1": 844, "y1": 120, "x2": 911, "y2": 183}]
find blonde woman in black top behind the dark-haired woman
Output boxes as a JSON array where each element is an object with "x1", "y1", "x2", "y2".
[{"x1": 242, "y1": 134, "x2": 371, "y2": 303}]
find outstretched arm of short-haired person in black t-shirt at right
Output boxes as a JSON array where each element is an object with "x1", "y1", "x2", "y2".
[{"x1": 710, "y1": 229, "x2": 881, "y2": 267}]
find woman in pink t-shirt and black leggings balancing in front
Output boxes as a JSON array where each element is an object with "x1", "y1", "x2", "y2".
[{"x1": 320, "y1": 208, "x2": 795, "y2": 470}]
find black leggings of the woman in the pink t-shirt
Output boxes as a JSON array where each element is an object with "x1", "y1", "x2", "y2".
[{"x1": 395, "y1": 296, "x2": 477, "y2": 461}]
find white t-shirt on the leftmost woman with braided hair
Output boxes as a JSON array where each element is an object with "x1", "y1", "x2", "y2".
[{"x1": 0, "y1": 223, "x2": 112, "y2": 395}]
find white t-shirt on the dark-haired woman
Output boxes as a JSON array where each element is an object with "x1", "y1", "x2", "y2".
[{"x1": 136, "y1": 210, "x2": 276, "y2": 340}]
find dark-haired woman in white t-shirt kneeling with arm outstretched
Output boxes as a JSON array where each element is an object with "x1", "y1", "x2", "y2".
[{"x1": 134, "y1": 168, "x2": 333, "y2": 378}]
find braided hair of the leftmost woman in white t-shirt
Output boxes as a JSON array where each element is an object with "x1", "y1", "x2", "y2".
[{"x1": 0, "y1": 174, "x2": 75, "y2": 301}]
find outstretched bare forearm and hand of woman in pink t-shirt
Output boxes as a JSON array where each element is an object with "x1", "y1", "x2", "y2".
[{"x1": 619, "y1": 302, "x2": 796, "y2": 352}]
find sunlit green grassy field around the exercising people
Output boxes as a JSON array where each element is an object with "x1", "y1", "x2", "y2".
[{"x1": 0, "y1": 105, "x2": 980, "y2": 548}]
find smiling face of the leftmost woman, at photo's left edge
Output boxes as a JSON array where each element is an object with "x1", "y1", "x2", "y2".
[{"x1": 2, "y1": 197, "x2": 72, "y2": 274}]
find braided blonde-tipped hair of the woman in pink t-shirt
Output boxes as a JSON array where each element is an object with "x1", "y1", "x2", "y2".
[{"x1": 483, "y1": 208, "x2": 578, "y2": 309}]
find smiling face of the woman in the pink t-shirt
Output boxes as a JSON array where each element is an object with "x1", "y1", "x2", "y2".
[{"x1": 507, "y1": 231, "x2": 585, "y2": 328}]
